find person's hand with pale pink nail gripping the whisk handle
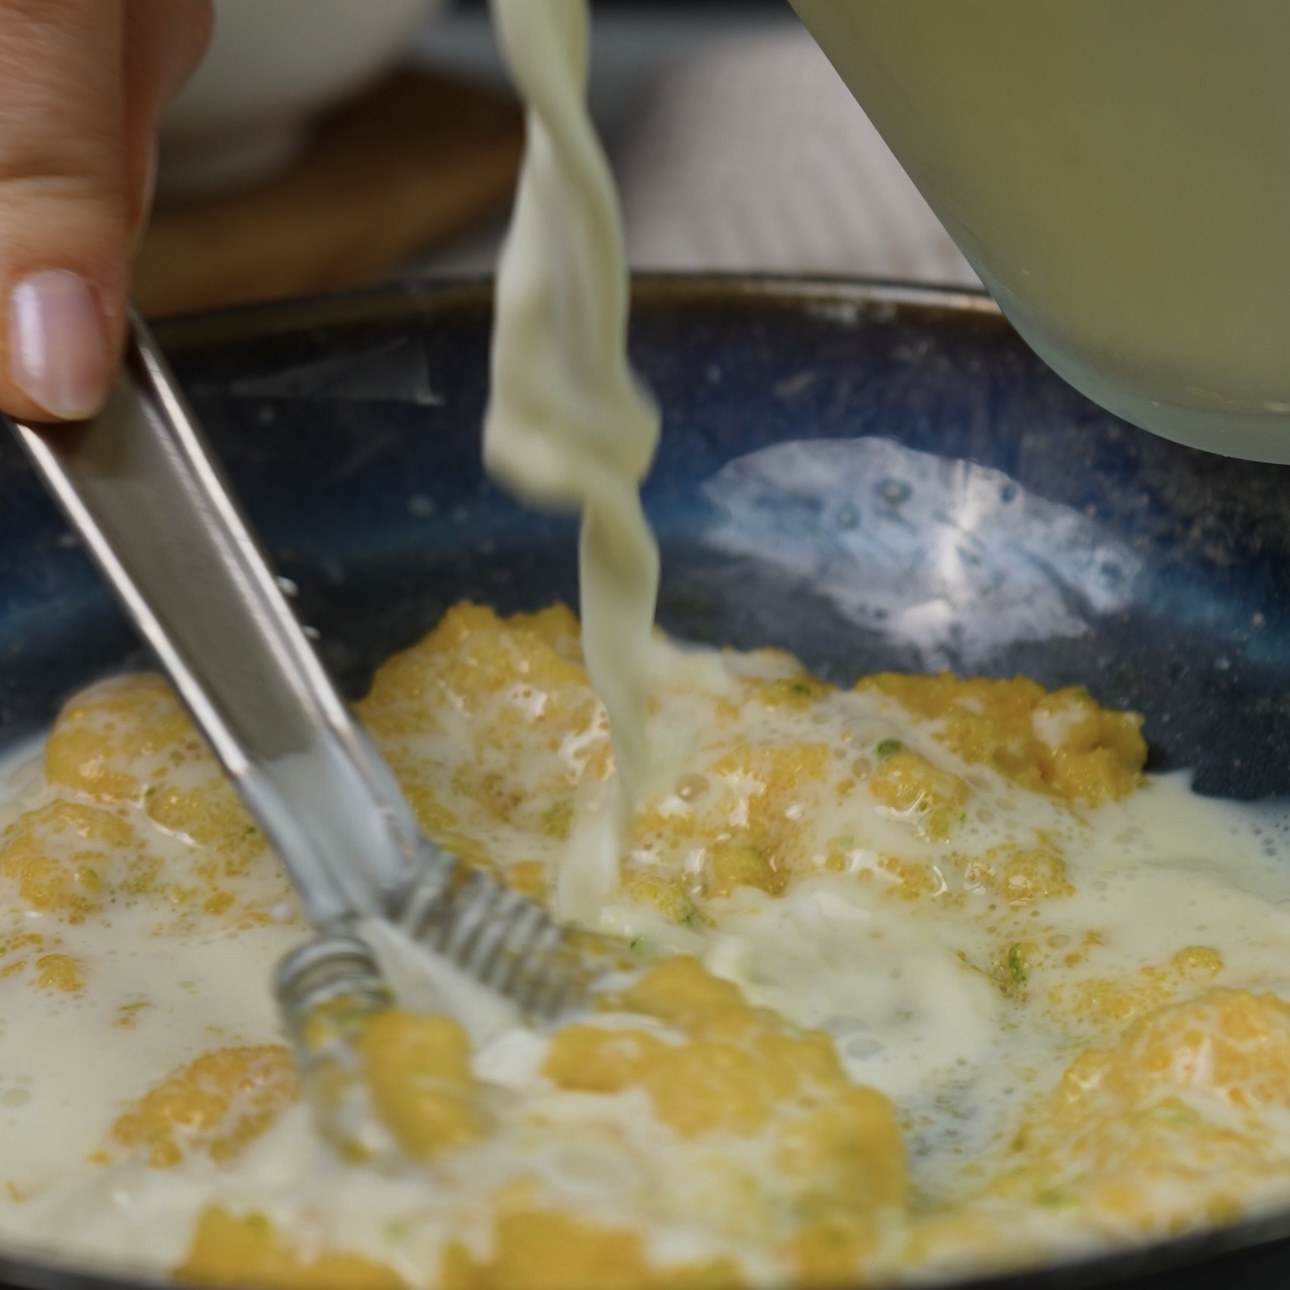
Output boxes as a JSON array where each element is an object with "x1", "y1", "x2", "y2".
[{"x1": 0, "y1": 0, "x2": 210, "y2": 421}]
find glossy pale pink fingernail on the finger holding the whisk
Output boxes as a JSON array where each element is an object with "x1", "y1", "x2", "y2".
[{"x1": 9, "y1": 268, "x2": 108, "y2": 421}]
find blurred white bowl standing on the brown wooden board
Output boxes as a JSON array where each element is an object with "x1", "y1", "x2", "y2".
[{"x1": 157, "y1": 0, "x2": 444, "y2": 195}]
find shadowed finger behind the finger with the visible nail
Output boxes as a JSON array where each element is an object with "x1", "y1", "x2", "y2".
[{"x1": 125, "y1": 0, "x2": 212, "y2": 240}]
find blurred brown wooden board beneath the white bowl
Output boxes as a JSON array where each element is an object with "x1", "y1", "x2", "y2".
[{"x1": 134, "y1": 72, "x2": 524, "y2": 316}]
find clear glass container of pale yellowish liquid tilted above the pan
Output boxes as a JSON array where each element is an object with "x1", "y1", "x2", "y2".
[{"x1": 792, "y1": 0, "x2": 1290, "y2": 462}]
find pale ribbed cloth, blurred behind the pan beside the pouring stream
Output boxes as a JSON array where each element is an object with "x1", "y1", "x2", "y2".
[{"x1": 615, "y1": 25, "x2": 979, "y2": 285}]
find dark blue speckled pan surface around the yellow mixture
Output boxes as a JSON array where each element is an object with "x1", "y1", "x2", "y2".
[{"x1": 0, "y1": 279, "x2": 1290, "y2": 1290}]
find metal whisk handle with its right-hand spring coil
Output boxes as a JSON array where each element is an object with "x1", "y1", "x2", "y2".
[{"x1": 5, "y1": 315, "x2": 596, "y2": 1020}]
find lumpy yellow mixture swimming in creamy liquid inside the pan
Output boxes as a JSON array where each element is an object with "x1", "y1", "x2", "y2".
[{"x1": 0, "y1": 605, "x2": 1290, "y2": 1290}]
